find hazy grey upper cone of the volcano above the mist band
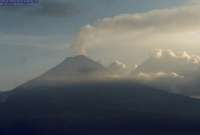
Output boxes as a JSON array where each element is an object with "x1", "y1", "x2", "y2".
[{"x1": 21, "y1": 55, "x2": 107, "y2": 87}]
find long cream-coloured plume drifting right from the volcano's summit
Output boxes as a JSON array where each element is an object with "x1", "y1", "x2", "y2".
[{"x1": 72, "y1": 1, "x2": 200, "y2": 62}]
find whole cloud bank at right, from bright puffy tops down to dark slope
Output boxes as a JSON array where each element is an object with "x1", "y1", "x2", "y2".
[{"x1": 131, "y1": 49, "x2": 200, "y2": 95}]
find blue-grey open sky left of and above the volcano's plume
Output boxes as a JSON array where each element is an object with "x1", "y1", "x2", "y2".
[{"x1": 0, "y1": 0, "x2": 190, "y2": 90}]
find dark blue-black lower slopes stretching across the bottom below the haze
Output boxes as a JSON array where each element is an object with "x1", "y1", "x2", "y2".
[{"x1": 0, "y1": 81, "x2": 200, "y2": 135}]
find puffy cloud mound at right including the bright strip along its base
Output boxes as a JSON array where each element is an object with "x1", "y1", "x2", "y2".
[{"x1": 132, "y1": 49, "x2": 200, "y2": 85}]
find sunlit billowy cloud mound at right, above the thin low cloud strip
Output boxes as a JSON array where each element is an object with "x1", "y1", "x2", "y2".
[{"x1": 133, "y1": 49, "x2": 200, "y2": 77}]
